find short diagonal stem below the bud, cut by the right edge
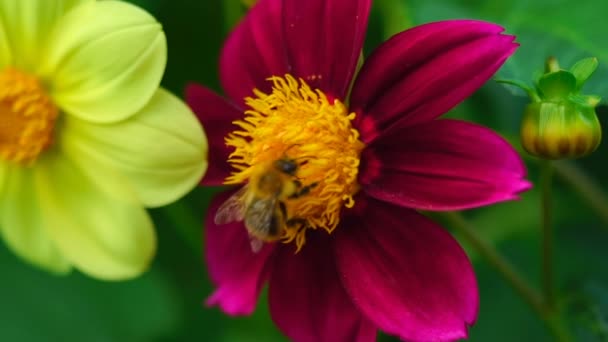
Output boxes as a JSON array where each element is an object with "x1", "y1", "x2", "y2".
[{"x1": 553, "y1": 161, "x2": 608, "y2": 227}]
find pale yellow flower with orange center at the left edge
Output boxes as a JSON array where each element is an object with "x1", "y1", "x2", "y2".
[{"x1": 0, "y1": 0, "x2": 207, "y2": 280}]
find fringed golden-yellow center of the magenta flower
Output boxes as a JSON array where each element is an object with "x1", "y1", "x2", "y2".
[{"x1": 225, "y1": 75, "x2": 364, "y2": 250}]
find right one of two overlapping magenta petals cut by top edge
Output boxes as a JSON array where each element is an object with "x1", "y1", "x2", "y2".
[{"x1": 283, "y1": 0, "x2": 371, "y2": 99}]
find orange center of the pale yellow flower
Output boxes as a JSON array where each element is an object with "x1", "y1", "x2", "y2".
[{"x1": 0, "y1": 68, "x2": 59, "y2": 164}]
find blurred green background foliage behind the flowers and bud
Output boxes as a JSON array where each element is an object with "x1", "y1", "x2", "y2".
[{"x1": 0, "y1": 0, "x2": 608, "y2": 342}]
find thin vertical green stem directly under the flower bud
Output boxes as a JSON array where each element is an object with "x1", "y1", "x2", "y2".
[{"x1": 540, "y1": 160, "x2": 555, "y2": 308}]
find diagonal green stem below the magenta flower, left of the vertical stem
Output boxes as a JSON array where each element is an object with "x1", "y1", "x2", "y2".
[{"x1": 438, "y1": 212, "x2": 573, "y2": 342}]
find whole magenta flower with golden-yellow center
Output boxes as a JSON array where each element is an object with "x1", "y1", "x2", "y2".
[{"x1": 186, "y1": 0, "x2": 530, "y2": 341}]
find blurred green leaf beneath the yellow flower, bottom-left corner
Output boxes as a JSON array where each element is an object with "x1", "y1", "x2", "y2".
[{"x1": 0, "y1": 244, "x2": 182, "y2": 342}]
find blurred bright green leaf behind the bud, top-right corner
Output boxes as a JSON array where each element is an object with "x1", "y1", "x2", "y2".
[{"x1": 408, "y1": 0, "x2": 608, "y2": 101}]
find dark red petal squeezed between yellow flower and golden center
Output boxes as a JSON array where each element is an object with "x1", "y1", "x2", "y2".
[{"x1": 185, "y1": 84, "x2": 243, "y2": 185}]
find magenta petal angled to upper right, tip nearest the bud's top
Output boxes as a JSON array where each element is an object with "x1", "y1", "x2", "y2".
[{"x1": 351, "y1": 20, "x2": 517, "y2": 143}]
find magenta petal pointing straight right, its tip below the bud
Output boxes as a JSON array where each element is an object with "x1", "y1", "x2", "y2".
[{"x1": 359, "y1": 120, "x2": 530, "y2": 210}]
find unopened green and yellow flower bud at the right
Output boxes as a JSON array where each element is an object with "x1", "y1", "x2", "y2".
[{"x1": 502, "y1": 58, "x2": 602, "y2": 159}]
